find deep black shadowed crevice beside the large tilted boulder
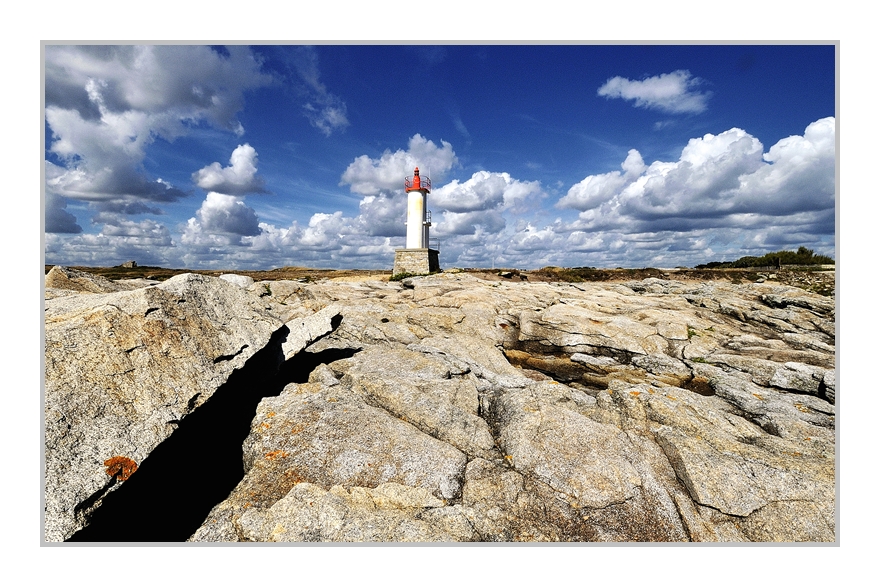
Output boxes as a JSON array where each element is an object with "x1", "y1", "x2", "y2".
[{"x1": 69, "y1": 327, "x2": 356, "y2": 542}]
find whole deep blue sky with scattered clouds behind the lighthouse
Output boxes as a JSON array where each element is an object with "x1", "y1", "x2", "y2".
[{"x1": 44, "y1": 44, "x2": 837, "y2": 269}]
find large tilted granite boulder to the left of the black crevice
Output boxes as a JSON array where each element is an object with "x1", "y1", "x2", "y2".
[{"x1": 44, "y1": 272, "x2": 282, "y2": 541}]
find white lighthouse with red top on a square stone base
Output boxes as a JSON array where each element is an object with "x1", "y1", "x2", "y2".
[{"x1": 392, "y1": 167, "x2": 440, "y2": 275}]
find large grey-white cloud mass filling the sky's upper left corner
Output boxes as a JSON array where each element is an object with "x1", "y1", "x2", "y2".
[{"x1": 45, "y1": 45, "x2": 271, "y2": 218}]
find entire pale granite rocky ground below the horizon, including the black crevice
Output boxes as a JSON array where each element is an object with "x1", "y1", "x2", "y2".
[{"x1": 45, "y1": 268, "x2": 837, "y2": 542}]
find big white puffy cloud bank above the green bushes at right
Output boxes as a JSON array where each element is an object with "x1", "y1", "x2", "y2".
[{"x1": 532, "y1": 117, "x2": 835, "y2": 267}]
